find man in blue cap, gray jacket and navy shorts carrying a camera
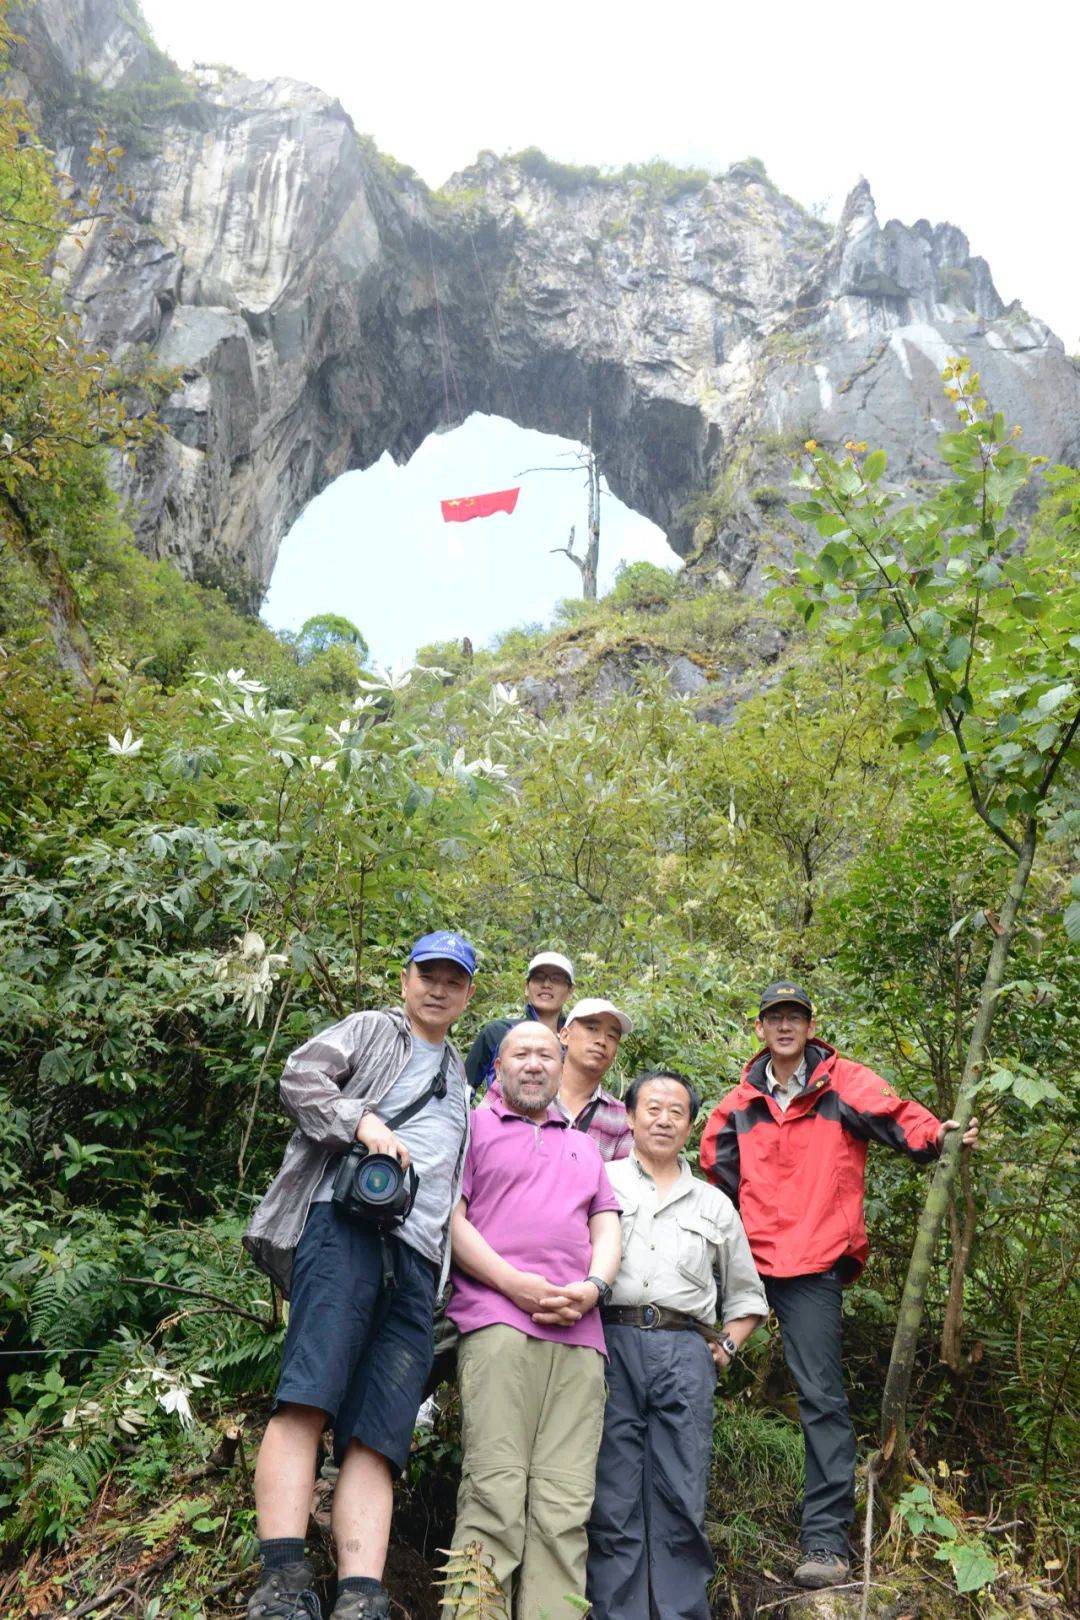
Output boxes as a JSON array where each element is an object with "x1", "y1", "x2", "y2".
[{"x1": 244, "y1": 933, "x2": 476, "y2": 1620}]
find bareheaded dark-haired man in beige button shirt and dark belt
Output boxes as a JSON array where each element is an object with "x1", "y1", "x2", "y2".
[{"x1": 586, "y1": 1069, "x2": 769, "y2": 1620}]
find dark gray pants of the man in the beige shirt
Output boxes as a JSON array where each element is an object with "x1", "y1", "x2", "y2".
[{"x1": 586, "y1": 1325, "x2": 716, "y2": 1620}]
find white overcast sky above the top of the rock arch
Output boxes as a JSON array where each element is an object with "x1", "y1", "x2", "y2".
[{"x1": 142, "y1": 0, "x2": 1080, "y2": 664}]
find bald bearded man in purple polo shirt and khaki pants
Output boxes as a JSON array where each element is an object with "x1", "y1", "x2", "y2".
[{"x1": 444, "y1": 1022, "x2": 620, "y2": 1620}]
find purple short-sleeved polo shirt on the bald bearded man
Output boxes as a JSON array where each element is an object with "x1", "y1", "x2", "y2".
[{"x1": 447, "y1": 1098, "x2": 620, "y2": 1354}]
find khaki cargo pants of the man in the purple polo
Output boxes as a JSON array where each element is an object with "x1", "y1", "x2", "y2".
[{"x1": 442, "y1": 1325, "x2": 604, "y2": 1620}]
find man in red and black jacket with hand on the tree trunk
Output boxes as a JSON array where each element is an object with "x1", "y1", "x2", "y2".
[{"x1": 701, "y1": 980, "x2": 978, "y2": 1586}]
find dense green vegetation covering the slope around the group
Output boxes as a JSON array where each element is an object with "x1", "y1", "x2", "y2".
[{"x1": 0, "y1": 9, "x2": 1080, "y2": 1620}]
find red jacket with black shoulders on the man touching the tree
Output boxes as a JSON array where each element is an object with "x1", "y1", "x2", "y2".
[{"x1": 701, "y1": 1040, "x2": 941, "y2": 1277}]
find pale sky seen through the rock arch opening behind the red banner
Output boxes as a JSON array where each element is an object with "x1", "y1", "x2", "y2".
[{"x1": 262, "y1": 416, "x2": 678, "y2": 664}]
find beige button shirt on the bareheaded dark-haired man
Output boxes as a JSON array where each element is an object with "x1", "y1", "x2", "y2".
[{"x1": 607, "y1": 1150, "x2": 769, "y2": 1327}]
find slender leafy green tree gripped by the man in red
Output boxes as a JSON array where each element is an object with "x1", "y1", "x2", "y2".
[{"x1": 792, "y1": 358, "x2": 1080, "y2": 1474}]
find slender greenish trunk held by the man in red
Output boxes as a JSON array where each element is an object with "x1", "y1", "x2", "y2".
[{"x1": 881, "y1": 816, "x2": 1038, "y2": 1481}]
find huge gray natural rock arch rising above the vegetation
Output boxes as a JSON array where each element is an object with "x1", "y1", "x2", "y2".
[{"x1": 15, "y1": 0, "x2": 1080, "y2": 596}]
